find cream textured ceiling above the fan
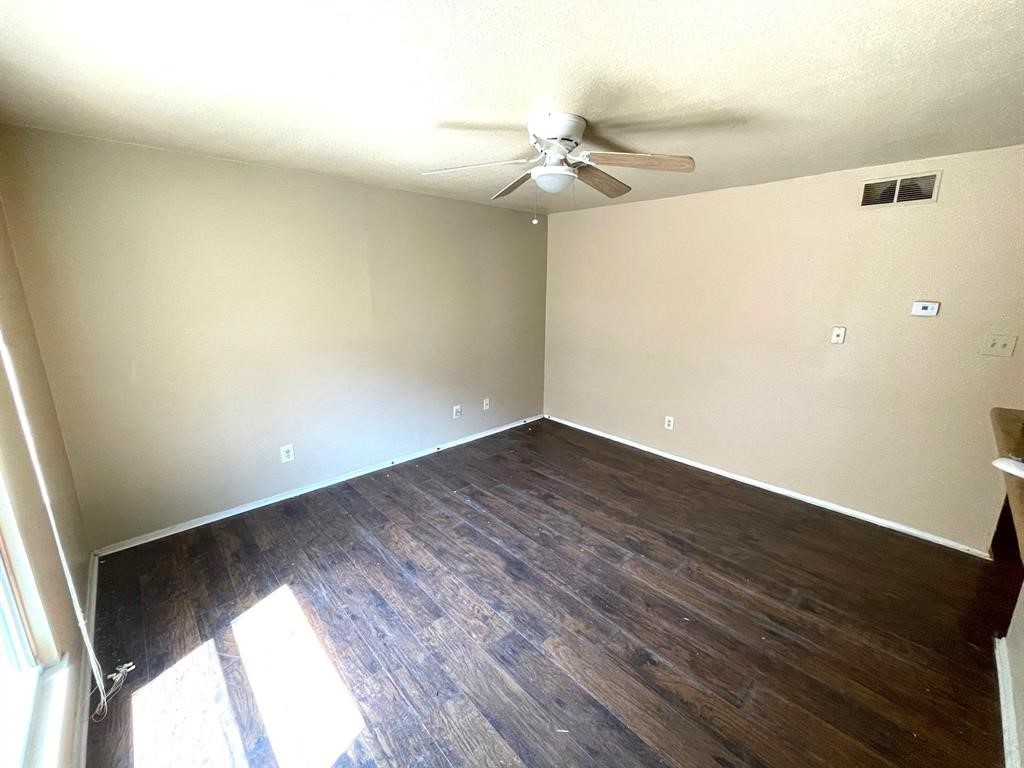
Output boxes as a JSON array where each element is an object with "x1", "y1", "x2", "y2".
[{"x1": 0, "y1": 0, "x2": 1024, "y2": 210}]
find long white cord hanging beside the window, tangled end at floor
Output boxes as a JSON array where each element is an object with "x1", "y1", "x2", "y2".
[{"x1": 0, "y1": 330, "x2": 135, "y2": 722}]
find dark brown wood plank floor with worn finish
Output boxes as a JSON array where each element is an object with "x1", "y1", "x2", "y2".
[{"x1": 88, "y1": 421, "x2": 1021, "y2": 768}]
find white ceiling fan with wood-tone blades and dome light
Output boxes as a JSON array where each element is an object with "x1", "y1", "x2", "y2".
[{"x1": 423, "y1": 112, "x2": 694, "y2": 200}]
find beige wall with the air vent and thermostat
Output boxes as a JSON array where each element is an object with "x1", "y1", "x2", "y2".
[{"x1": 545, "y1": 146, "x2": 1024, "y2": 550}]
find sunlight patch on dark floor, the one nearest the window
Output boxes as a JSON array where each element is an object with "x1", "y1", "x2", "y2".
[{"x1": 131, "y1": 640, "x2": 249, "y2": 768}]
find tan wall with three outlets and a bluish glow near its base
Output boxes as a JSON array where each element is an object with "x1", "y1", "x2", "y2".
[{"x1": 0, "y1": 128, "x2": 546, "y2": 545}]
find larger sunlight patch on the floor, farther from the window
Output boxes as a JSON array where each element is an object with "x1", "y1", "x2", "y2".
[{"x1": 231, "y1": 586, "x2": 365, "y2": 768}]
